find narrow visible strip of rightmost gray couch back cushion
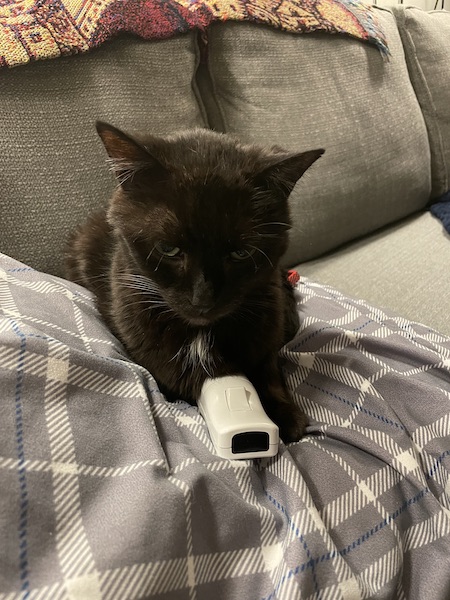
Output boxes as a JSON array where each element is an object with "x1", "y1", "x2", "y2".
[{"x1": 394, "y1": 6, "x2": 450, "y2": 198}]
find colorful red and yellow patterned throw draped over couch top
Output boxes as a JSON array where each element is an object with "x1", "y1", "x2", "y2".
[{"x1": 0, "y1": 0, "x2": 389, "y2": 67}]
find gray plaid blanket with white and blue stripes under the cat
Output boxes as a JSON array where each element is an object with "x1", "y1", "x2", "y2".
[{"x1": 0, "y1": 257, "x2": 450, "y2": 600}]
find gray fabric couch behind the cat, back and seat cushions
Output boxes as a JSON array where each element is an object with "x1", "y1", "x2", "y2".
[{"x1": 0, "y1": 7, "x2": 450, "y2": 334}]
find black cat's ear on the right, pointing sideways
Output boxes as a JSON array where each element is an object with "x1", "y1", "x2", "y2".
[{"x1": 258, "y1": 148, "x2": 325, "y2": 195}]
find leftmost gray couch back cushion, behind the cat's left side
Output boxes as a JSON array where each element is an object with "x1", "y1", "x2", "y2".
[{"x1": 0, "y1": 34, "x2": 205, "y2": 275}]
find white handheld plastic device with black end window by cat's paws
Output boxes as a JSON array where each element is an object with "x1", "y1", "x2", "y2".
[{"x1": 197, "y1": 375, "x2": 279, "y2": 459}]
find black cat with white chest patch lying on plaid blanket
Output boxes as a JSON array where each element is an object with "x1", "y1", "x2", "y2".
[{"x1": 67, "y1": 123, "x2": 323, "y2": 442}]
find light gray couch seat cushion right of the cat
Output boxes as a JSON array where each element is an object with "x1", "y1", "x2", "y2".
[{"x1": 298, "y1": 212, "x2": 450, "y2": 335}]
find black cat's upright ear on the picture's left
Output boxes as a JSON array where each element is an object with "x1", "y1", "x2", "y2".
[{"x1": 95, "y1": 121, "x2": 164, "y2": 189}]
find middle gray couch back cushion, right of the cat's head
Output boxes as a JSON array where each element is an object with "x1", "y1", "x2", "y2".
[{"x1": 199, "y1": 10, "x2": 430, "y2": 265}]
